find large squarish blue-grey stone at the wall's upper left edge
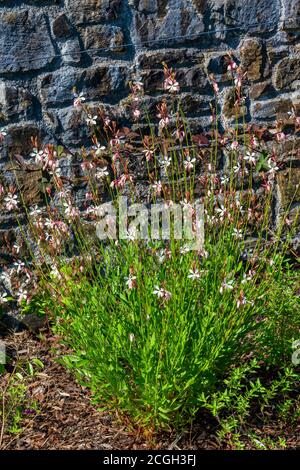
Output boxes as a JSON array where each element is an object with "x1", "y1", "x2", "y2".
[{"x1": 0, "y1": 10, "x2": 55, "y2": 73}]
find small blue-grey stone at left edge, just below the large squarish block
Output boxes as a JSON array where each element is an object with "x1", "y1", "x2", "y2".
[{"x1": 0, "y1": 82, "x2": 34, "y2": 122}]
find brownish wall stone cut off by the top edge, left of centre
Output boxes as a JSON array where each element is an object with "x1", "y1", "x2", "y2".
[{"x1": 65, "y1": 0, "x2": 121, "y2": 24}]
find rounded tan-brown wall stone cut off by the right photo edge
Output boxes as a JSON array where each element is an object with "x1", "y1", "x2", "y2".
[{"x1": 273, "y1": 57, "x2": 300, "y2": 90}]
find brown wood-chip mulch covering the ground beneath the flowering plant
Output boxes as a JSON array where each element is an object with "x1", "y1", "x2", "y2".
[{"x1": 0, "y1": 331, "x2": 300, "y2": 450}]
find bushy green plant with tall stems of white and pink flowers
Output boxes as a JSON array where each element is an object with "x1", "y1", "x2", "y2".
[{"x1": 0, "y1": 57, "x2": 300, "y2": 447}]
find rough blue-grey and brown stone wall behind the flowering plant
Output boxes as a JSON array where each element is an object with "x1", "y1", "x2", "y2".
[{"x1": 0, "y1": 0, "x2": 300, "y2": 326}]
